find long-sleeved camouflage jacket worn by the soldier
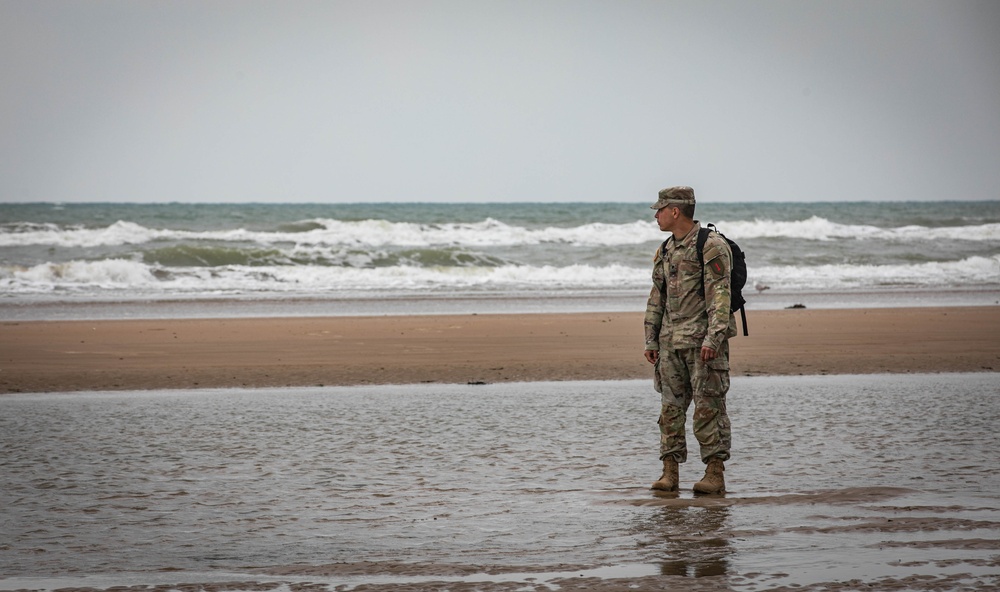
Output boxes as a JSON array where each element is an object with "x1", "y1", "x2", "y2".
[{"x1": 644, "y1": 221, "x2": 736, "y2": 351}]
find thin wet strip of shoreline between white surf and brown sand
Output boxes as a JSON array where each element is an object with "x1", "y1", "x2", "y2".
[{"x1": 0, "y1": 289, "x2": 1000, "y2": 322}]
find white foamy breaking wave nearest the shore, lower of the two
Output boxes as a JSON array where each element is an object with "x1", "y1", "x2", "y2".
[{"x1": 0, "y1": 256, "x2": 1000, "y2": 295}]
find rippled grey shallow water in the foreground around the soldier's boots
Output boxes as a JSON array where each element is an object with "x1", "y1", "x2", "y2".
[{"x1": 0, "y1": 373, "x2": 1000, "y2": 590}]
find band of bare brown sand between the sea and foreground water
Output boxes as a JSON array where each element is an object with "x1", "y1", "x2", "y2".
[{"x1": 0, "y1": 307, "x2": 1000, "y2": 393}]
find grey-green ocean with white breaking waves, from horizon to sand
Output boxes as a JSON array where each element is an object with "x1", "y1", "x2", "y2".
[{"x1": 0, "y1": 201, "x2": 1000, "y2": 318}]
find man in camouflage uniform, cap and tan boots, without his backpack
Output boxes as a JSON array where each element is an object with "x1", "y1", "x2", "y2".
[{"x1": 644, "y1": 187, "x2": 736, "y2": 493}]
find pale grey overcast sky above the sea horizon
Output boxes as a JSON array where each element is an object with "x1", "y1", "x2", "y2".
[{"x1": 0, "y1": 0, "x2": 1000, "y2": 202}]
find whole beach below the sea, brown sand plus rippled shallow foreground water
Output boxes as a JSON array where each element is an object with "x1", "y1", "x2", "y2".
[{"x1": 0, "y1": 307, "x2": 1000, "y2": 592}]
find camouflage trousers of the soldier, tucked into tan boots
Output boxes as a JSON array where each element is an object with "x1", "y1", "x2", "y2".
[{"x1": 654, "y1": 341, "x2": 733, "y2": 463}]
